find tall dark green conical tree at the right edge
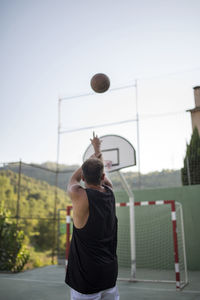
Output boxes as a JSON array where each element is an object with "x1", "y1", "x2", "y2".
[{"x1": 181, "y1": 127, "x2": 200, "y2": 185}]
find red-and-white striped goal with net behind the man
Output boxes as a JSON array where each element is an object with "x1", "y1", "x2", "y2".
[{"x1": 66, "y1": 200, "x2": 188, "y2": 290}]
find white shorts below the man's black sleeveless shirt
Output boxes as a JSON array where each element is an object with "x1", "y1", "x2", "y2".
[{"x1": 71, "y1": 286, "x2": 119, "y2": 300}]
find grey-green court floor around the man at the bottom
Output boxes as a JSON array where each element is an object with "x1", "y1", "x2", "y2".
[{"x1": 0, "y1": 266, "x2": 200, "y2": 300}]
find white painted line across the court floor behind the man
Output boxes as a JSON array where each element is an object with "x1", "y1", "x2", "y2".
[{"x1": 0, "y1": 276, "x2": 200, "y2": 294}]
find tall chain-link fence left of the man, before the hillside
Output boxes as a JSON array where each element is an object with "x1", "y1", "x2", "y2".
[{"x1": 0, "y1": 161, "x2": 73, "y2": 264}]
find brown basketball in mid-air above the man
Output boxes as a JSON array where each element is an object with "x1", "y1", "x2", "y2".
[{"x1": 90, "y1": 73, "x2": 110, "y2": 93}]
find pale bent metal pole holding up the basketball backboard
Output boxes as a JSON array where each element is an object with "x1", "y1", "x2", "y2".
[{"x1": 118, "y1": 171, "x2": 136, "y2": 279}]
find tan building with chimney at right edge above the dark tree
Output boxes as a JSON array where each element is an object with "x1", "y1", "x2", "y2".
[{"x1": 187, "y1": 86, "x2": 200, "y2": 135}]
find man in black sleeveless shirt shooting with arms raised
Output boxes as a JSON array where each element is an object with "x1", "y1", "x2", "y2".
[{"x1": 65, "y1": 133, "x2": 119, "y2": 300}]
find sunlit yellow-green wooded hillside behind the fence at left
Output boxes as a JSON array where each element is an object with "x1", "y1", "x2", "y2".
[{"x1": 0, "y1": 170, "x2": 70, "y2": 218}]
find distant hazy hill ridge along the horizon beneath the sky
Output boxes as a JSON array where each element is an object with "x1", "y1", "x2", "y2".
[{"x1": 2, "y1": 162, "x2": 182, "y2": 190}]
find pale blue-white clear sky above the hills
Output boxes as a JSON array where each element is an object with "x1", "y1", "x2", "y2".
[{"x1": 0, "y1": 0, "x2": 200, "y2": 173}]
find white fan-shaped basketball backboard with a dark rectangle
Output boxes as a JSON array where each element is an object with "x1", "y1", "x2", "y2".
[{"x1": 83, "y1": 135, "x2": 136, "y2": 172}]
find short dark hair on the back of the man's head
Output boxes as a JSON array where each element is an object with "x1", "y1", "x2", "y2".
[{"x1": 82, "y1": 158, "x2": 103, "y2": 185}]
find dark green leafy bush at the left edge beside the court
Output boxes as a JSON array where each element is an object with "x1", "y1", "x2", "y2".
[{"x1": 0, "y1": 202, "x2": 29, "y2": 272}]
